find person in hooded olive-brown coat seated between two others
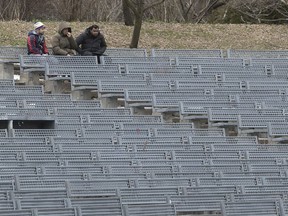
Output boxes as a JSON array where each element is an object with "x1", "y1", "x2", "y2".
[{"x1": 51, "y1": 22, "x2": 78, "y2": 56}]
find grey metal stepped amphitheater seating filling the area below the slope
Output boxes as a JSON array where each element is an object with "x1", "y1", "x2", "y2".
[{"x1": 0, "y1": 47, "x2": 288, "y2": 216}]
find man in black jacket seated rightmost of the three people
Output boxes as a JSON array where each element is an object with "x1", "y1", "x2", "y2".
[{"x1": 76, "y1": 25, "x2": 107, "y2": 62}]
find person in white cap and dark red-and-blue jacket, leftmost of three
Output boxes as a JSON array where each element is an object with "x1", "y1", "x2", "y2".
[{"x1": 27, "y1": 22, "x2": 49, "y2": 55}]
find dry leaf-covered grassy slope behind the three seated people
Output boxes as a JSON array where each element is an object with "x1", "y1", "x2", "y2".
[{"x1": 0, "y1": 21, "x2": 288, "y2": 50}]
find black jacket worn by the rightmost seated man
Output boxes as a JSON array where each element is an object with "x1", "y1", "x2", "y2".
[{"x1": 76, "y1": 28, "x2": 107, "y2": 55}]
